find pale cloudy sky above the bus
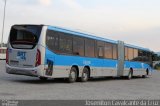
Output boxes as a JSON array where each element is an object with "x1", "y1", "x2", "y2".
[{"x1": 0, "y1": 0, "x2": 160, "y2": 52}]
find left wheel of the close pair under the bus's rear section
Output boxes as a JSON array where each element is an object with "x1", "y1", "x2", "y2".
[{"x1": 68, "y1": 67, "x2": 77, "y2": 83}]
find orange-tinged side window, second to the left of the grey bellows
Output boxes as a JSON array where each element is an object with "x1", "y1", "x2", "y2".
[{"x1": 104, "y1": 43, "x2": 113, "y2": 59}]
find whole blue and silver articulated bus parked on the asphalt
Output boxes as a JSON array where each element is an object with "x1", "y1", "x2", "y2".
[{"x1": 6, "y1": 25, "x2": 152, "y2": 82}]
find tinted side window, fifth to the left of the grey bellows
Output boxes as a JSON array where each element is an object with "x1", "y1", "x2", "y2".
[{"x1": 73, "y1": 37, "x2": 84, "y2": 56}]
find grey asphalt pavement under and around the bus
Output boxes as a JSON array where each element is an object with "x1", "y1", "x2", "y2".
[{"x1": 0, "y1": 60, "x2": 160, "y2": 100}]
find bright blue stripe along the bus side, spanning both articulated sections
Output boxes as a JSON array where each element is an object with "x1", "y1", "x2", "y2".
[{"x1": 45, "y1": 49, "x2": 151, "y2": 69}]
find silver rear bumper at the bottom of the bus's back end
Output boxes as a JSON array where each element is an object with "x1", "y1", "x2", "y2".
[{"x1": 6, "y1": 64, "x2": 42, "y2": 77}]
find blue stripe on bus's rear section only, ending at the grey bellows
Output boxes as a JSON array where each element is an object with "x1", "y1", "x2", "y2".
[{"x1": 45, "y1": 49, "x2": 117, "y2": 68}]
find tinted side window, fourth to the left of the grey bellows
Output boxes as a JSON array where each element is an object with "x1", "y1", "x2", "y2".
[{"x1": 85, "y1": 39, "x2": 95, "y2": 57}]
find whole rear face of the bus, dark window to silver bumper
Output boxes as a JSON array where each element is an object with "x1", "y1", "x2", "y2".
[{"x1": 6, "y1": 25, "x2": 43, "y2": 76}]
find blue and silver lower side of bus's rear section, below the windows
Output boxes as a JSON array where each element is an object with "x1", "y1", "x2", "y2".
[{"x1": 45, "y1": 49, "x2": 117, "y2": 78}]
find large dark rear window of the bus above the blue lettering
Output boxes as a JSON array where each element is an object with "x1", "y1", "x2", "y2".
[{"x1": 10, "y1": 25, "x2": 41, "y2": 49}]
